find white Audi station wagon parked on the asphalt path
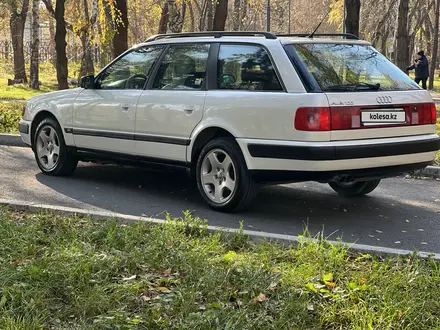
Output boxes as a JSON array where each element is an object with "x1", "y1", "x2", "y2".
[{"x1": 19, "y1": 32, "x2": 440, "y2": 211}]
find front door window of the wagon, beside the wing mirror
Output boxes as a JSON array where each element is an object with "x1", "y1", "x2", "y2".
[{"x1": 97, "y1": 46, "x2": 163, "y2": 89}]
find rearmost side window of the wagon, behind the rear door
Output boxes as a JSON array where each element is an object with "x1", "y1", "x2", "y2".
[{"x1": 217, "y1": 45, "x2": 283, "y2": 91}]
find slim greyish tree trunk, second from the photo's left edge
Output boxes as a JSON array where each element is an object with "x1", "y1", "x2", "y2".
[{"x1": 29, "y1": 0, "x2": 40, "y2": 90}]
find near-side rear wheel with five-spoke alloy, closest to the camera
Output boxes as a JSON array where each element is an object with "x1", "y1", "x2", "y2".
[{"x1": 196, "y1": 138, "x2": 258, "y2": 212}]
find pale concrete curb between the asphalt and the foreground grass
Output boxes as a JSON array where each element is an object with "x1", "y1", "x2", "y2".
[{"x1": 0, "y1": 199, "x2": 440, "y2": 261}]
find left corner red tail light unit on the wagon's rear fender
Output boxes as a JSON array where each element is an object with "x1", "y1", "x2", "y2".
[{"x1": 295, "y1": 108, "x2": 330, "y2": 131}]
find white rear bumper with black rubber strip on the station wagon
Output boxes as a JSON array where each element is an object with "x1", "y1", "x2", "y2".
[{"x1": 237, "y1": 134, "x2": 440, "y2": 181}]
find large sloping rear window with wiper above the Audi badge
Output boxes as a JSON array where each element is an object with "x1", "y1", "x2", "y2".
[{"x1": 291, "y1": 44, "x2": 419, "y2": 92}]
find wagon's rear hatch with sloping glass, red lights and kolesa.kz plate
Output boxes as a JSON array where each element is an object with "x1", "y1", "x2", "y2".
[{"x1": 285, "y1": 39, "x2": 436, "y2": 140}]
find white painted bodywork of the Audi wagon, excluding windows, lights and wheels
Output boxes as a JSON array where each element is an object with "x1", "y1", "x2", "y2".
[{"x1": 21, "y1": 37, "x2": 436, "y2": 182}]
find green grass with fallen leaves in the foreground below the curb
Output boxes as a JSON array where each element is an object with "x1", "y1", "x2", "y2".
[{"x1": 0, "y1": 209, "x2": 440, "y2": 330}]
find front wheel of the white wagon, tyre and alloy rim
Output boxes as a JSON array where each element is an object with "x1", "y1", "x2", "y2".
[{"x1": 32, "y1": 118, "x2": 78, "y2": 176}]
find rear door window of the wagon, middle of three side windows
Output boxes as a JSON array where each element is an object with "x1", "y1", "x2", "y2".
[{"x1": 153, "y1": 44, "x2": 209, "y2": 90}]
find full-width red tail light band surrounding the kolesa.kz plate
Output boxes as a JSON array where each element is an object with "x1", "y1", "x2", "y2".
[{"x1": 295, "y1": 103, "x2": 437, "y2": 131}]
